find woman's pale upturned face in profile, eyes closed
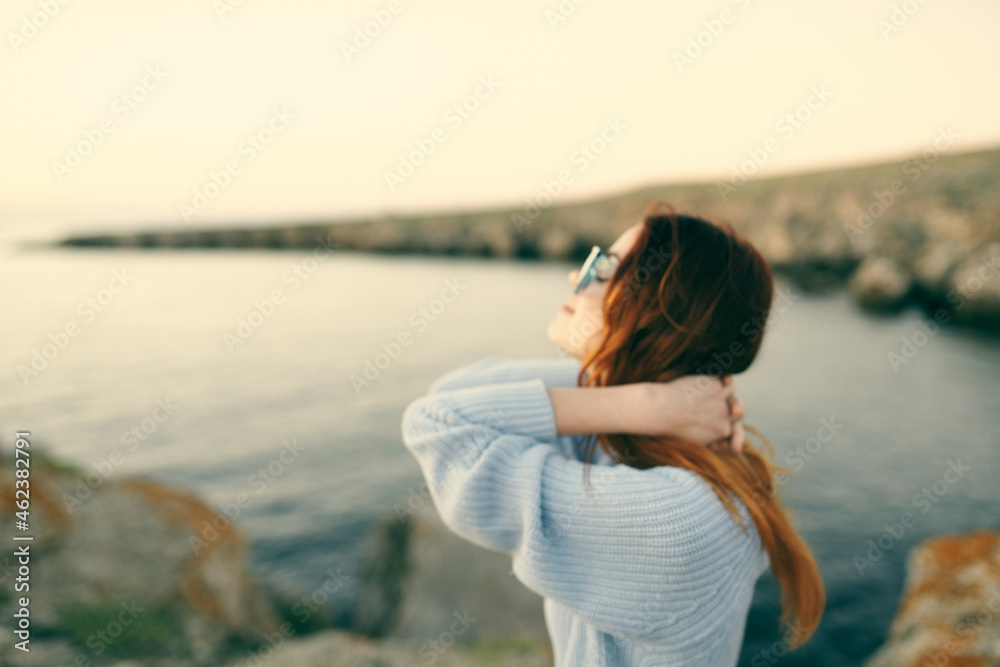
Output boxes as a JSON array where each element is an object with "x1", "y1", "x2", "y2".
[{"x1": 547, "y1": 223, "x2": 642, "y2": 361}]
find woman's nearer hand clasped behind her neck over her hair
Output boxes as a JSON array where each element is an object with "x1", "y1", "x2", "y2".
[{"x1": 628, "y1": 375, "x2": 745, "y2": 452}]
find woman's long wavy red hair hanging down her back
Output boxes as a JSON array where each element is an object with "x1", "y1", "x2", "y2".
[{"x1": 577, "y1": 200, "x2": 826, "y2": 649}]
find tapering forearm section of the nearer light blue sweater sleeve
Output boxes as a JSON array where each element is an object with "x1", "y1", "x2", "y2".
[{"x1": 431, "y1": 378, "x2": 559, "y2": 442}]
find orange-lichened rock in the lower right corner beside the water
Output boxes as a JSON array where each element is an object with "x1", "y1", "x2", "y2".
[{"x1": 865, "y1": 530, "x2": 1000, "y2": 667}]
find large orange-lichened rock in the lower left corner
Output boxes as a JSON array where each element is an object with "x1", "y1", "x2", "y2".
[{"x1": 0, "y1": 443, "x2": 278, "y2": 665}]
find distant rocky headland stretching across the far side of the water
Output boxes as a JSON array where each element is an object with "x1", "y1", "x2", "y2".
[{"x1": 54, "y1": 147, "x2": 1000, "y2": 331}]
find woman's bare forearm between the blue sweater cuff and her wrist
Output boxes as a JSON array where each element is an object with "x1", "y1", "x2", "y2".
[{"x1": 548, "y1": 384, "x2": 641, "y2": 436}]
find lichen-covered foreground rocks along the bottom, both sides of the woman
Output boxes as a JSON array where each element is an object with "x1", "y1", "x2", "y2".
[{"x1": 0, "y1": 444, "x2": 1000, "y2": 667}]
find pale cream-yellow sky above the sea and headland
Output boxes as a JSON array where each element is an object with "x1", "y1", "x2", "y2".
[{"x1": 0, "y1": 0, "x2": 1000, "y2": 235}]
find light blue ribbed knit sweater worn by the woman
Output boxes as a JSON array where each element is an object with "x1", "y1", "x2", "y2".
[{"x1": 402, "y1": 357, "x2": 770, "y2": 667}]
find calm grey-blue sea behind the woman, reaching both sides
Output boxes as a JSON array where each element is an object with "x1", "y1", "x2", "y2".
[{"x1": 0, "y1": 234, "x2": 1000, "y2": 666}]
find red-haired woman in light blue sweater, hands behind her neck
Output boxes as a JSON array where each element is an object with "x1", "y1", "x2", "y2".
[{"x1": 402, "y1": 202, "x2": 826, "y2": 667}]
